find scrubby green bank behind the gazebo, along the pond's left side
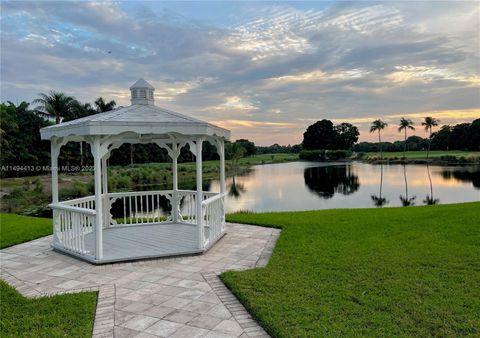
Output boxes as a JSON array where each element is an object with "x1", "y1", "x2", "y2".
[{"x1": 0, "y1": 154, "x2": 298, "y2": 216}]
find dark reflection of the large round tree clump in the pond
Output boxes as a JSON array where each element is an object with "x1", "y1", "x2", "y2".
[{"x1": 303, "y1": 165, "x2": 360, "y2": 198}]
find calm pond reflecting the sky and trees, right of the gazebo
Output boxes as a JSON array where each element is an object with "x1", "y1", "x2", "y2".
[{"x1": 209, "y1": 162, "x2": 480, "y2": 213}]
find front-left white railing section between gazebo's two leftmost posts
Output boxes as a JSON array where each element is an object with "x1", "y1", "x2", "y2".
[{"x1": 49, "y1": 203, "x2": 96, "y2": 255}]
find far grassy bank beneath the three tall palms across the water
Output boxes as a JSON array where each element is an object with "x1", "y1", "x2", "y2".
[{"x1": 363, "y1": 150, "x2": 480, "y2": 161}]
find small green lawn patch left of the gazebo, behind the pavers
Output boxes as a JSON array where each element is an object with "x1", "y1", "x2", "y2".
[{"x1": 0, "y1": 213, "x2": 53, "y2": 249}]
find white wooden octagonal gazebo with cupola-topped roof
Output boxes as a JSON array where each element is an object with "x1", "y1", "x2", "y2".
[{"x1": 41, "y1": 79, "x2": 230, "y2": 263}]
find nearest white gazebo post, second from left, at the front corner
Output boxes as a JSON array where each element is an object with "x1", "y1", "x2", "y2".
[{"x1": 92, "y1": 137, "x2": 103, "y2": 260}]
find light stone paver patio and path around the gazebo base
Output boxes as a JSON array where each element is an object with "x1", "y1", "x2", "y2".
[{"x1": 0, "y1": 224, "x2": 280, "y2": 338}]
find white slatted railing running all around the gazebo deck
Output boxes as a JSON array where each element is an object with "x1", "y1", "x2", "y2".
[{"x1": 49, "y1": 190, "x2": 225, "y2": 256}]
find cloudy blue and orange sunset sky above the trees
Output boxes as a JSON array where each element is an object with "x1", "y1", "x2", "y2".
[{"x1": 0, "y1": 1, "x2": 480, "y2": 145}]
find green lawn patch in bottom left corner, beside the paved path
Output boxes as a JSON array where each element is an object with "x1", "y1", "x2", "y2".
[{"x1": 0, "y1": 281, "x2": 97, "y2": 337}]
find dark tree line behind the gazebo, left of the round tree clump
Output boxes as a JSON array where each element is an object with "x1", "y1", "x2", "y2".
[{"x1": 0, "y1": 92, "x2": 301, "y2": 177}]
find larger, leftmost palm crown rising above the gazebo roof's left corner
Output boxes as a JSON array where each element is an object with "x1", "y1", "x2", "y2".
[{"x1": 32, "y1": 90, "x2": 78, "y2": 124}]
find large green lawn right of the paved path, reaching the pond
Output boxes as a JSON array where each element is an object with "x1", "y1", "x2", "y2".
[{"x1": 221, "y1": 203, "x2": 480, "y2": 337}]
